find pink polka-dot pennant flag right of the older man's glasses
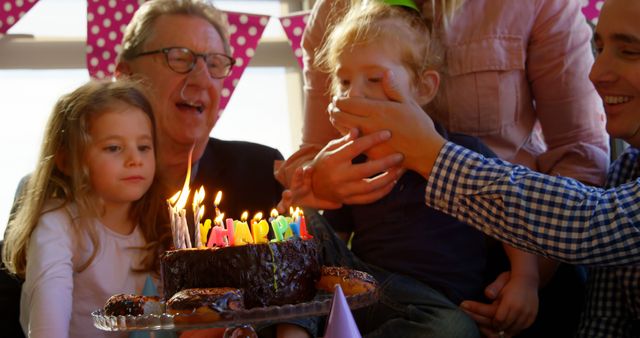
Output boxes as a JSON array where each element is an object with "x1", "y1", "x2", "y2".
[{"x1": 220, "y1": 12, "x2": 270, "y2": 111}]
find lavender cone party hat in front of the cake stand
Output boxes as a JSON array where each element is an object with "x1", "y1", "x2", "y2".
[{"x1": 324, "y1": 284, "x2": 362, "y2": 338}]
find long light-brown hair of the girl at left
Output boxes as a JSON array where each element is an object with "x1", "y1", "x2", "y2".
[{"x1": 2, "y1": 80, "x2": 170, "y2": 278}]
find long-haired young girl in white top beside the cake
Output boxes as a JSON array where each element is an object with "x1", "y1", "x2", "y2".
[{"x1": 3, "y1": 80, "x2": 170, "y2": 337}]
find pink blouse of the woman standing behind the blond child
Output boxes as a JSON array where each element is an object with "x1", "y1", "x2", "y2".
[{"x1": 276, "y1": 0, "x2": 609, "y2": 186}]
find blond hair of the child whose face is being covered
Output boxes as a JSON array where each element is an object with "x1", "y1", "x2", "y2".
[{"x1": 315, "y1": 0, "x2": 442, "y2": 97}]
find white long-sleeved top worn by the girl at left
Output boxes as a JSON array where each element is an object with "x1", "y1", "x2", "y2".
[{"x1": 20, "y1": 206, "x2": 147, "y2": 338}]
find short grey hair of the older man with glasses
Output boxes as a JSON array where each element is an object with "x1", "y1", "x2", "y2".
[{"x1": 117, "y1": 0, "x2": 231, "y2": 62}]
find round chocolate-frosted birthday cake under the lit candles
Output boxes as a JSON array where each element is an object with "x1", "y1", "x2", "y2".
[{"x1": 160, "y1": 238, "x2": 321, "y2": 308}]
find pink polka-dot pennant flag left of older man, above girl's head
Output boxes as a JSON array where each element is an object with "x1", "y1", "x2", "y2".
[{"x1": 87, "y1": 0, "x2": 140, "y2": 79}]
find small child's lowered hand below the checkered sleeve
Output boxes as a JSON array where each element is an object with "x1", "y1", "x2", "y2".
[{"x1": 493, "y1": 272, "x2": 538, "y2": 336}]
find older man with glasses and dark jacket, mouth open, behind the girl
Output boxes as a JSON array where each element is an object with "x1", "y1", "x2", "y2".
[{"x1": 116, "y1": 0, "x2": 282, "y2": 224}]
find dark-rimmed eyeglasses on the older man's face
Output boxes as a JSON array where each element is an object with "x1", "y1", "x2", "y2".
[{"x1": 135, "y1": 47, "x2": 236, "y2": 79}]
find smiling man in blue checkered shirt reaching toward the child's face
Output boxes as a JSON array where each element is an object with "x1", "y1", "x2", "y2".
[{"x1": 331, "y1": 0, "x2": 640, "y2": 337}]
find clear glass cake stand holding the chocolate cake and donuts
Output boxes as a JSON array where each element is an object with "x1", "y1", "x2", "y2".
[{"x1": 91, "y1": 289, "x2": 378, "y2": 337}]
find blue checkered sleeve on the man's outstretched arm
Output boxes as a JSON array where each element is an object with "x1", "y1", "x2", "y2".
[{"x1": 425, "y1": 142, "x2": 640, "y2": 266}]
